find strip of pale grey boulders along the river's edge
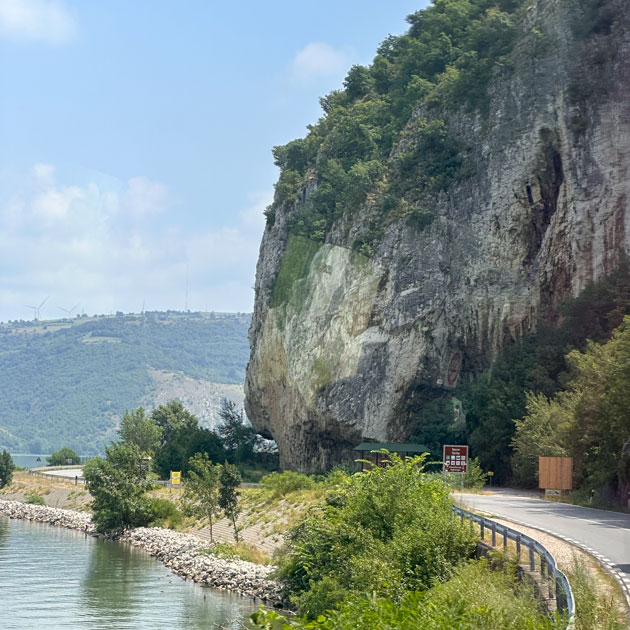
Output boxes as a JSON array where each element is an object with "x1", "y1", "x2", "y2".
[{"x1": 0, "y1": 500, "x2": 283, "y2": 606}]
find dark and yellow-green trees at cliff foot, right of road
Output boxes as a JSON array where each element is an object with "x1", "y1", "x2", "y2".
[{"x1": 414, "y1": 258, "x2": 630, "y2": 503}]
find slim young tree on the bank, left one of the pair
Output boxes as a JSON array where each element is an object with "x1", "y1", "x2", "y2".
[{"x1": 182, "y1": 453, "x2": 221, "y2": 542}]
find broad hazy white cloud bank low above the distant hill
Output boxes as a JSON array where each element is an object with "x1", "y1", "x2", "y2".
[{"x1": 0, "y1": 164, "x2": 272, "y2": 321}]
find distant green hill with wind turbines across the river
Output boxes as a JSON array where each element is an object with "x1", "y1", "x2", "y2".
[{"x1": 0, "y1": 311, "x2": 250, "y2": 453}]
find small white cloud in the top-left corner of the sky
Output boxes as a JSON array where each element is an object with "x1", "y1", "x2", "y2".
[{"x1": 0, "y1": 0, "x2": 77, "y2": 44}]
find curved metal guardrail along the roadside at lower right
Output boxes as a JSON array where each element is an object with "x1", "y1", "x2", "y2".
[{"x1": 453, "y1": 505, "x2": 575, "y2": 630}]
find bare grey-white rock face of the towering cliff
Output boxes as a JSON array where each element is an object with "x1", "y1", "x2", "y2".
[{"x1": 246, "y1": 0, "x2": 630, "y2": 471}]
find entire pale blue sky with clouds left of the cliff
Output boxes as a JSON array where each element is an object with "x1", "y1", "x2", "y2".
[{"x1": 0, "y1": 0, "x2": 428, "y2": 321}]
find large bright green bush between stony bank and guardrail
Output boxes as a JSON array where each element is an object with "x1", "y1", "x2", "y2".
[{"x1": 278, "y1": 455, "x2": 476, "y2": 618}]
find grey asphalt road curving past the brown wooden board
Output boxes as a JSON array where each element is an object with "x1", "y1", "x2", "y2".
[{"x1": 457, "y1": 490, "x2": 630, "y2": 581}]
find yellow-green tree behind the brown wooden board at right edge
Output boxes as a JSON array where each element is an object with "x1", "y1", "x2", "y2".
[{"x1": 514, "y1": 316, "x2": 630, "y2": 500}]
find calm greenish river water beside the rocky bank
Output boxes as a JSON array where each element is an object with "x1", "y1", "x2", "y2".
[{"x1": 0, "y1": 515, "x2": 257, "y2": 630}]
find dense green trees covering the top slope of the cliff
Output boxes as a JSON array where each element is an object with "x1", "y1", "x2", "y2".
[{"x1": 266, "y1": 0, "x2": 528, "y2": 244}]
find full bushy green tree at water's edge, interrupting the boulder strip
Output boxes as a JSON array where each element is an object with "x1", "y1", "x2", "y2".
[{"x1": 83, "y1": 444, "x2": 151, "y2": 533}]
